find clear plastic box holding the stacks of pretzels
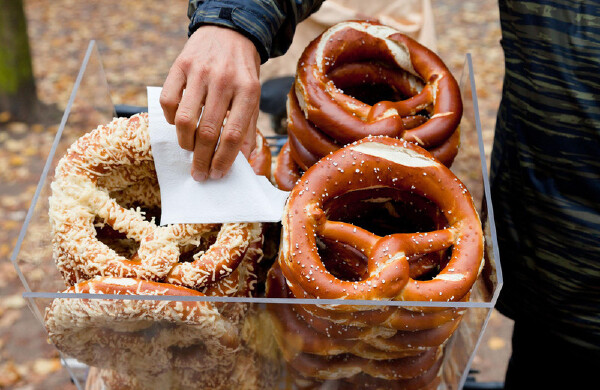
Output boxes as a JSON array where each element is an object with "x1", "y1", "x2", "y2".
[{"x1": 12, "y1": 41, "x2": 502, "y2": 389}]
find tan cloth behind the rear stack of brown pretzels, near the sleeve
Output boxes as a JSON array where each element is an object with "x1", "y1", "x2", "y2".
[{"x1": 261, "y1": 0, "x2": 437, "y2": 81}]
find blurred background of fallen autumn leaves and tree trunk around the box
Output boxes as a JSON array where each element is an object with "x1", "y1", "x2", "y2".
[{"x1": 0, "y1": 0, "x2": 512, "y2": 390}]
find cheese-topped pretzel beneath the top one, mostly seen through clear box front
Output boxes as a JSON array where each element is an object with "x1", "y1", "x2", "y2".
[{"x1": 45, "y1": 277, "x2": 241, "y2": 373}]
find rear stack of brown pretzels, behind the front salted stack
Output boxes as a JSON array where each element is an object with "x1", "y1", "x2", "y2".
[{"x1": 274, "y1": 21, "x2": 462, "y2": 190}]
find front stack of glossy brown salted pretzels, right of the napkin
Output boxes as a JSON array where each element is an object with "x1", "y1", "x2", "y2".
[{"x1": 267, "y1": 136, "x2": 483, "y2": 389}]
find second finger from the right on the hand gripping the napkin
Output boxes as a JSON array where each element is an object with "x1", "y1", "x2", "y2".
[{"x1": 192, "y1": 85, "x2": 233, "y2": 181}]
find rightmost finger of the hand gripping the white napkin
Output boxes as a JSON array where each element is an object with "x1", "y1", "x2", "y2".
[{"x1": 210, "y1": 81, "x2": 260, "y2": 179}]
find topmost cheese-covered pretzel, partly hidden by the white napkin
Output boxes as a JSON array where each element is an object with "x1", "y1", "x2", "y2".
[{"x1": 49, "y1": 114, "x2": 268, "y2": 289}]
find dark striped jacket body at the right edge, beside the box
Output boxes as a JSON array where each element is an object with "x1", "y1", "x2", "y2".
[{"x1": 491, "y1": 0, "x2": 600, "y2": 350}]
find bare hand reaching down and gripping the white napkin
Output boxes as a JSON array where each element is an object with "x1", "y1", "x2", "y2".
[{"x1": 160, "y1": 25, "x2": 260, "y2": 181}]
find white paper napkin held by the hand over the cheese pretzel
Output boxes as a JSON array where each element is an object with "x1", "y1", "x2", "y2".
[{"x1": 148, "y1": 87, "x2": 289, "y2": 225}]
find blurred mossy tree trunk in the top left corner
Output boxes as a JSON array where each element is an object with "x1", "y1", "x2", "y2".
[{"x1": 0, "y1": 0, "x2": 39, "y2": 121}]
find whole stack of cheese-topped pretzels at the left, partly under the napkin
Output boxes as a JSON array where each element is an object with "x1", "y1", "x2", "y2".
[{"x1": 45, "y1": 114, "x2": 276, "y2": 389}]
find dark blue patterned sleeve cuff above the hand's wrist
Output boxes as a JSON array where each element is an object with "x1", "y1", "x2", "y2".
[{"x1": 188, "y1": 0, "x2": 323, "y2": 63}]
